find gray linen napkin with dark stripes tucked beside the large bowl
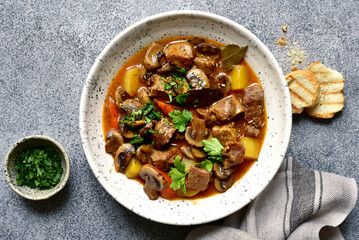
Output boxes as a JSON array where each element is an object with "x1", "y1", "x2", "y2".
[{"x1": 186, "y1": 157, "x2": 358, "y2": 240}]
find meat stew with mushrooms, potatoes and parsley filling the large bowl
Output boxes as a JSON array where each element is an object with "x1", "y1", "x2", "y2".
[{"x1": 103, "y1": 36, "x2": 266, "y2": 200}]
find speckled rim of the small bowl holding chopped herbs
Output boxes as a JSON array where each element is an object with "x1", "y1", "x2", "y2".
[{"x1": 4, "y1": 135, "x2": 71, "y2": 200}]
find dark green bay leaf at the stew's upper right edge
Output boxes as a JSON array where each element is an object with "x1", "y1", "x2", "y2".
[{"x1": 221, "y1": 44, "x2": 248, "y2": 71}]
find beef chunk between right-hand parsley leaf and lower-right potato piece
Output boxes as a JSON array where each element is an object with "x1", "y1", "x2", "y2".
[{"x1": 222, "y1": 142, "x2": 246, "y2": 169}]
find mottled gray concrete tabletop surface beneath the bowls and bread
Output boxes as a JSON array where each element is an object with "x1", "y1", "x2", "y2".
[{"x1": 0, "y1": 0, "x2": 359, "y2": 239}]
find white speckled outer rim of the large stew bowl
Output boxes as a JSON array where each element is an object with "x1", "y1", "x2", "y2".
[{"x1": 79, "y1": 10, "x2": 292, "y2": 225}]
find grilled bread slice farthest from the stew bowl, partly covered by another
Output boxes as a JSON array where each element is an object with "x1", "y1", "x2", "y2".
[{"x1": 305, "y1": 62, "x2": 345, "y2": 118}]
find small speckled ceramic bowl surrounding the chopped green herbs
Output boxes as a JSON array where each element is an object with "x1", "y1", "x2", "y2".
[{"x1": 4, "y1": 135, "x2": 70, "y2": 200}]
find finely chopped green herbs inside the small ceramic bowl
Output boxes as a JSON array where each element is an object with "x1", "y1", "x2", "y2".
[{"x1": 15, "y1": 148, "x2": 63, "y2": 190}]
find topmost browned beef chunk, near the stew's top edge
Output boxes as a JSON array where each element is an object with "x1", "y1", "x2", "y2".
[{"x1": 164, "y1": 41, "x2": 194, "y2": 69}]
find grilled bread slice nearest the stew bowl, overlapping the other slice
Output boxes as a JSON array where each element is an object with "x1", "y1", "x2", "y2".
[{"x1": 285, "y1": 70, "x2": 319, "y2": 114}]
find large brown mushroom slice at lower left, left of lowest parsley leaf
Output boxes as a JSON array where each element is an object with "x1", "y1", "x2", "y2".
[{"x1": 140, "y1": 164, "x2": 167, "y2": 191}]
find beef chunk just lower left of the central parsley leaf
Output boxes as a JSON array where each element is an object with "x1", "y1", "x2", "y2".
[{"x1": 151, "y1": 118, "x2": 176, "y2": 149}]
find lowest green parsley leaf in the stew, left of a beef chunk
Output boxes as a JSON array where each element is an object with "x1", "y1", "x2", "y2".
[{"x1": 168, "y1": 156, "x2": 189, "y2": 194}]
